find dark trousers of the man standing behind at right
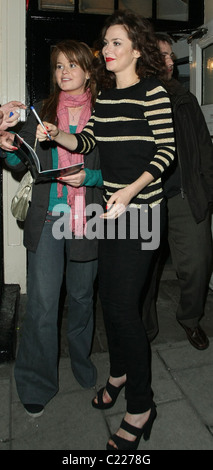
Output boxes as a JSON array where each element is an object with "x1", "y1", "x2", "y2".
[{"x1": 168, "y1": 195, "x2": 212, "y2": 328}]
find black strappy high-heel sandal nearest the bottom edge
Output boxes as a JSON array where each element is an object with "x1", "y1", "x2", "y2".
[{"x1": 106, "y1": 403, "x2": 157, "y2": 451}]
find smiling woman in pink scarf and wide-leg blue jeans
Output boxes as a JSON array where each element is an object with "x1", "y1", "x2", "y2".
[{"x1": 7, "y1": 40, "x2": 102, "y2": 417}]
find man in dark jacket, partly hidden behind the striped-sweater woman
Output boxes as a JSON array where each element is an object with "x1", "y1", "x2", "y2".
[{"x1": 143, "y1": 34, "x2": 213, "y2": 350}]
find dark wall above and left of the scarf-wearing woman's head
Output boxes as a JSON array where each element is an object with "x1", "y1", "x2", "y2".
[{"x1": 27, "y1": 7, "x2": 105, "y2": 103}]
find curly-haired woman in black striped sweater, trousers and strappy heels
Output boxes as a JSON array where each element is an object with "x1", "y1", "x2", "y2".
[{"x1": 37, "y1": 11, "x2": 175, "y2": 450}]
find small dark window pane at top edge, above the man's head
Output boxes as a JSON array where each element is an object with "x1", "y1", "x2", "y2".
[{"x1": 157, "y1": 0, "x2": 189, "y2": 21}]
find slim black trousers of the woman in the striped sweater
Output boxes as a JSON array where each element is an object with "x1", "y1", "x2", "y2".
[{"x1": 99, "y1": 205, "x2": 165, "y2": 414}]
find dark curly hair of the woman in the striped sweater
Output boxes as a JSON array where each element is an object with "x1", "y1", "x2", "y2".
[{"x1": 93, "y1": 10, "x2": 165, "y2": 88}]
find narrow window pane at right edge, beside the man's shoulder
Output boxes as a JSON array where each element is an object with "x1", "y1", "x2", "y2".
[{"x1": 202, "y1": 44, "x2": 213, "y2": 104}]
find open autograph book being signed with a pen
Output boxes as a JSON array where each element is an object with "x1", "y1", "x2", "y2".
[{"x1": 14, "y1": 134, "x2": 84, "y2": 179}]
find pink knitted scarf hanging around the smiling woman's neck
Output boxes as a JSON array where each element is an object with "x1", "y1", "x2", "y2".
[{"x1": 57, "y1": 90, "x2": 91, "y2": 237}]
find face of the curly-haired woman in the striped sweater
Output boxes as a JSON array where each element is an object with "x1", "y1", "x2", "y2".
[{"x1": 102, "y1": 25, "x2": 140, "y2": 74}]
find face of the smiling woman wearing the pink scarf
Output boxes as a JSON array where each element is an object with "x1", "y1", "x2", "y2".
[{"x1": 55, "y1": 52, "x2": 89, "y2": 95}]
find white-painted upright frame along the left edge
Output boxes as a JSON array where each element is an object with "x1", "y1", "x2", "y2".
[{"x1": 0, "y1": 0, "x2": 26, "y2": 293}]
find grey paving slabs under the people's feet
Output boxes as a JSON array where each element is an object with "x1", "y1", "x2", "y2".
[{"x1": 0, "y1": 265, "x2": 213, "y2": 453}]
